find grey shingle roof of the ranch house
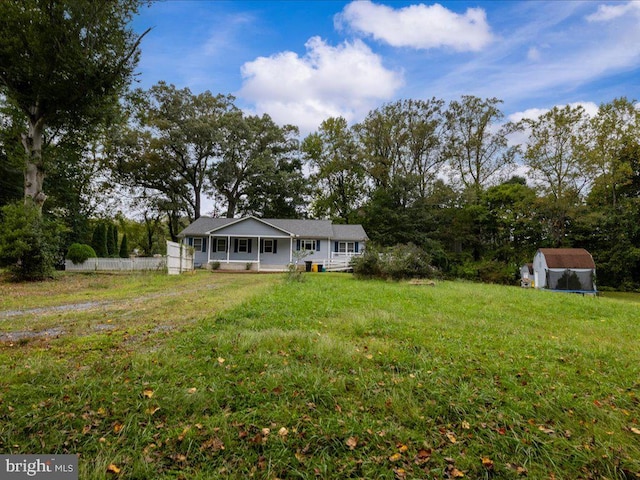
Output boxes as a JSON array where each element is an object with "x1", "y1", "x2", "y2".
[{"x1": 178, "y1": 217, "x2": 368, "y2": 241}]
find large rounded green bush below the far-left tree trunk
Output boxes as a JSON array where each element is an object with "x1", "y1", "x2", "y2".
[{"x1": 0, "y1": 202, "x2": 63, "y2": 281}]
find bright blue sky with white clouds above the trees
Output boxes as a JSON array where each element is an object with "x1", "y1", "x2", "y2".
[{"x1": 134, "y1": 0, "x2": 640, "y2": 135}]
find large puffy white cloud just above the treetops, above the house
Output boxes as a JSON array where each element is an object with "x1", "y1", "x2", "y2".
[{"x1": 239, "y1": 37, "x2": 403, "y2": 132}]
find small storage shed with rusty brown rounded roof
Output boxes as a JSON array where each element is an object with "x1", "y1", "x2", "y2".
[{"x1": 533, "y1": 248, "x2": 596, "y2": 292}]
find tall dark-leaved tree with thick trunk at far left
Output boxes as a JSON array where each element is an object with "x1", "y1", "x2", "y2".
[{"x1": 0, "y1": 0, "x2": 144, "y2": 210}]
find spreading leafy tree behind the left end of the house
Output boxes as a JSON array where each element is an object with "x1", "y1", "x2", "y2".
[{"x1": 111, "y1": 82, "x2": 237, "y2": 220}]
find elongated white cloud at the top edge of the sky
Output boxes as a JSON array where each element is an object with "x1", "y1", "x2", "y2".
[{"x1": 336, "y1": 0, "x2": 493, "y2": 51}]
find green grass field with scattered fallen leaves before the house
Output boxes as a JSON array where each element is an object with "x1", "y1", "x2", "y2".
[{"x1": 0, "y1": 272, "x2": 640, "y2": 479}]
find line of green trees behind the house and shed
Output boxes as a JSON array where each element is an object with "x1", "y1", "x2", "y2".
[{"x1": 0, "y1": 0, "x2": 640, "y2": 289}]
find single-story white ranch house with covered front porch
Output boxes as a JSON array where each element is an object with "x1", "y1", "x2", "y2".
[{"x1": 178, "y1": 216, "x2": 369, "y2": 271}]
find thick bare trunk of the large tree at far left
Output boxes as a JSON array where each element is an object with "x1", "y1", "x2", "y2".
[{"x1": 22, "y1": 112, "x2": 47, "y2": 211}]
